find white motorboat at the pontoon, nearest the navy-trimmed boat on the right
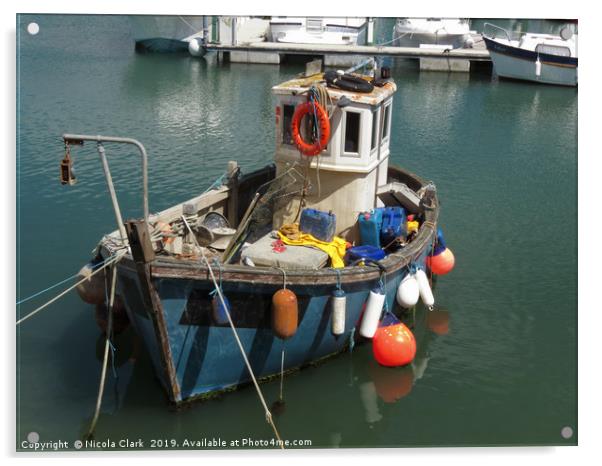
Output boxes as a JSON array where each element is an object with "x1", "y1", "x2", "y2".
[{"x1": 392, "y1": 18, "x2": 473, "y2": 48}]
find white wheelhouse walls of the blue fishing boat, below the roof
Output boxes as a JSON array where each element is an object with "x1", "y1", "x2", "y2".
[{"x1": 273, "y1": 95, "x2": 392, "y2": 242}]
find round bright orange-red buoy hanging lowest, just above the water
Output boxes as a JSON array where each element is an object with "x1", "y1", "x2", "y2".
[{"x1": 372, "y1": 322, "x2": 416, "y2": 367}]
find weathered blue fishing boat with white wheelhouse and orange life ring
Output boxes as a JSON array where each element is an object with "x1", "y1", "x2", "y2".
[{"x1": 61, "y1": 61, "x2": 439, "y2": 405}]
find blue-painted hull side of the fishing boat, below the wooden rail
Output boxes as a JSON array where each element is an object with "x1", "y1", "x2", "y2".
[{"x1": 113, "y1": 249, "x2": 428, "y2": 403}]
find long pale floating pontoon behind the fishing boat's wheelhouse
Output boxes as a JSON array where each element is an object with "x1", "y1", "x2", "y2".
[{"x1": 206, "y1": 36, "x2": 491, "y2": 71}]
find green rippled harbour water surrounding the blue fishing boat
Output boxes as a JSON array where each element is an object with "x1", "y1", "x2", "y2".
[{"x1": 16, "y1": 15, "x2": 578, "y2": 450}]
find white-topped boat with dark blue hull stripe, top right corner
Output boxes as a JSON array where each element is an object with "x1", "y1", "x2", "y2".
[{"x1": 483, "y1": 23, "x2": 578, "y2": 86}]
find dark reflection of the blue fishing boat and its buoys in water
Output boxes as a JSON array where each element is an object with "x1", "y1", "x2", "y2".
[{"x1": 80, "y1": 306, "x2": 449, "y2": 447}]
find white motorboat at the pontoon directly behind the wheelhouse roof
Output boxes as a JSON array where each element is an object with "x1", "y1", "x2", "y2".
[{"x1": 269, "y1": 16, "x2": 368, "y2": 45}]
